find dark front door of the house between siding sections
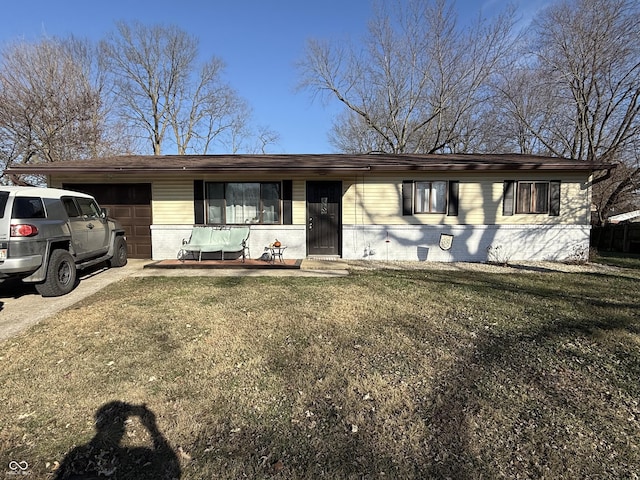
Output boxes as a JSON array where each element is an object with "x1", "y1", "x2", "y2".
[{"x1": 307, "y1": 182, "x2": 342, "y2": 255}]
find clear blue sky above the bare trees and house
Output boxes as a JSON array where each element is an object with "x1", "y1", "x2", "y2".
[{"x1": 0, "y1": 0, "x2": 549, "y2": 153}]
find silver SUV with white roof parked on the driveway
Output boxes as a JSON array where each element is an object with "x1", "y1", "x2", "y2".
[{"x1": 0, "y1": 186, "x2": 127, "y2": 297}]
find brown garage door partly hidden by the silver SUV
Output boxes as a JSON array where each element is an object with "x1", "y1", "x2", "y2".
[{"x1": 62, "y1": 183, "x2": 151, "y2": 258}]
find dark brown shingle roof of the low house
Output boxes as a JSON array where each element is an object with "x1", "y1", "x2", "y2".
[{"x1": 6, "y1": 154, "x2": 611, "y2": 174}]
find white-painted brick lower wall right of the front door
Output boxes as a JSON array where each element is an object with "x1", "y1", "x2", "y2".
[{"x1": 342, "y1": 225, "x2": 590, "y2": 263}]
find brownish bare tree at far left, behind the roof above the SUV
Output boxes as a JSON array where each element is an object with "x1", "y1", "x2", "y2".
[{"x1": 0, "y1": 38, "x2": 122, "y2": 183}]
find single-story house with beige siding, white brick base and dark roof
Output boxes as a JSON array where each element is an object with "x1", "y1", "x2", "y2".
[{"x1": 7, "y1": 154, "x2": 610, "y2": 262}]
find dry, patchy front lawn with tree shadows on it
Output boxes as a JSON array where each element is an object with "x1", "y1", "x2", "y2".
[{"x1": 0, "y1": 270, "x2": 640, "y2": 479}]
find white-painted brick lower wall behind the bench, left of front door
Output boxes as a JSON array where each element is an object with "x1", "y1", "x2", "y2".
[{"x1": 151, "y1": 225, "x2": 307, "y2": 260}]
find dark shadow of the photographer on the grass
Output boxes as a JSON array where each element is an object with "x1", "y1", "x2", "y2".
[{"x1": 55, "y1": 401, "x2": 181, "y2": 480}]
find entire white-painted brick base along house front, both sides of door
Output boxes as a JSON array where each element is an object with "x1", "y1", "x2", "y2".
[{"x1": 151, "y1": 225, "x2": 590, "y2": 263}]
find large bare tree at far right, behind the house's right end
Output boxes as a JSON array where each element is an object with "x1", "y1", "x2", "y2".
[{"x1": 499, "y1": 0, "x2": 640, "y2": 222}]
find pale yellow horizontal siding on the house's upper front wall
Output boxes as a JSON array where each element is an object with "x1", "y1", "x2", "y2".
[{"x1": 49, "y1": 171, "x2": 590, "y2": 225}]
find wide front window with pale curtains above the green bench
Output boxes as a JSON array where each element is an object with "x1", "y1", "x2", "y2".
[{"x1": 206, "y1": 182, "x2": 280, "y2": 225}]
